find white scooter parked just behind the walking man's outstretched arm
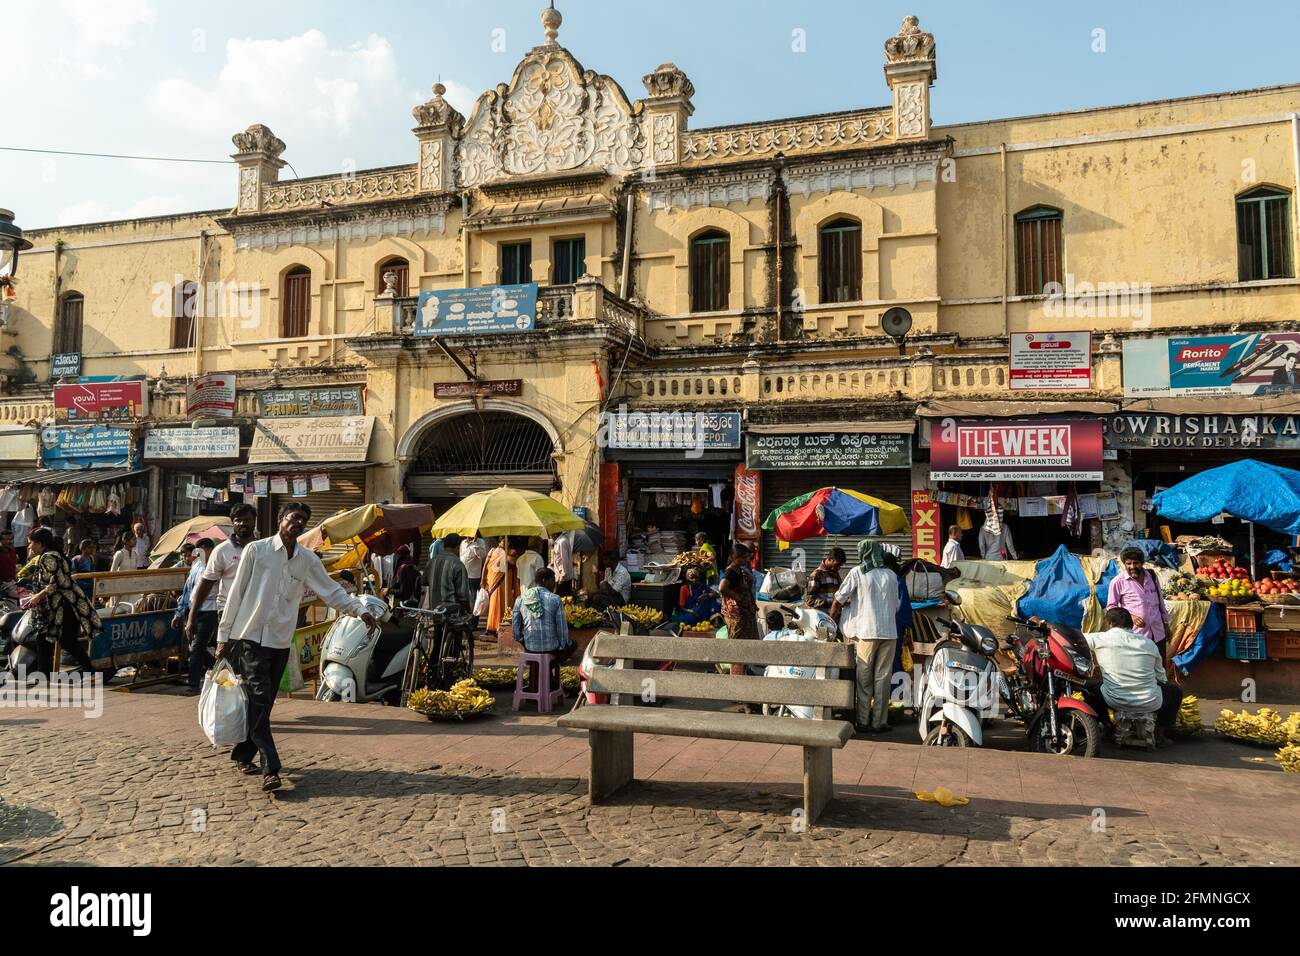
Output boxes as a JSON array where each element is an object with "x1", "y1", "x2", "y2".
[{"x1": 316, "y1": 594, "x2": 415, "y2": 705}]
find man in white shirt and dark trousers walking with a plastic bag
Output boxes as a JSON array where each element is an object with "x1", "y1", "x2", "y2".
[{"x1": 217, "y1": 501, "x2": 378, "y2": 791}]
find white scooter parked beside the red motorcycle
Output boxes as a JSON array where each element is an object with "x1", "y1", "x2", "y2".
[{"x1": 918, "y1": 591, "x2": 1001, "y2": 747}]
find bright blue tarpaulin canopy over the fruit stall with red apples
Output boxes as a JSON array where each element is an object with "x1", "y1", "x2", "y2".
[{"x1": 1152, "y1": 458, "x2": 1300, "y2": 535}]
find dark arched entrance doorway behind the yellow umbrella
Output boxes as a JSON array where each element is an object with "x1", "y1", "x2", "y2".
[{"x1": 406, "y1": 408, "x2": 559, "y2": 512}]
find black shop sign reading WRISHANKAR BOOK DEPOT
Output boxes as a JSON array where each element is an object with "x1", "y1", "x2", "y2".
[{"x1": 1105, "y1": 412, "x2": 1300, "y2": 449}]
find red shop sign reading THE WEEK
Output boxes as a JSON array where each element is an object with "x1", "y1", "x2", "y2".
[{"x1": 930, "y1": 419, "x2": 1102, "y2": 481}]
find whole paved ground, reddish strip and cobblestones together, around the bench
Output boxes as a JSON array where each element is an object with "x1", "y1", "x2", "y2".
[{"x1": 0, "y1": 691, "x2": 1300, "y2": 865}]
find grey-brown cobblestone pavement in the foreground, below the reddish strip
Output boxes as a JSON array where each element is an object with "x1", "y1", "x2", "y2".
[{"x1": 0, "y1": 721, "x2": 1300, "y2": 866}]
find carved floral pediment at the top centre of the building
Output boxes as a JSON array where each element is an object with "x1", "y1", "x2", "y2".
[{"x1": 456, "y1": 43, "x2": 646, "y2": 186}]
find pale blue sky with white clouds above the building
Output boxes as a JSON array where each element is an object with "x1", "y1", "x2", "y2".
[{"x1": 0, "y1": 0, "x2": 1300, "y2": 229}]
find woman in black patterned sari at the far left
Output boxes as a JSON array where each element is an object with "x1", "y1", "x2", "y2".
[{"x1": 18, "y1": 528, "x2": 104, "y2": 674}]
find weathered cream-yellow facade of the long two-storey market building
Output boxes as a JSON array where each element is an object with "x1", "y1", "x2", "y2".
[{"x1": 0, "y1": 9, "x2": 1300, "y2": 554}]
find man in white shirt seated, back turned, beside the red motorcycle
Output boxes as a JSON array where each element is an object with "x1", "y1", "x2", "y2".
[{"x1": 1083, "y1": 607, "x2": 1183, "y2": 744}]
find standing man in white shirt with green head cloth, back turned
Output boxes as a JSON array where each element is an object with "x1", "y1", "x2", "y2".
[{"x1": 831, "y1": 541, "x2": 898, "y2": 734}]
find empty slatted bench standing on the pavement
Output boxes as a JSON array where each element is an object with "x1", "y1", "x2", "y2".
[{"x1": 559, "y1": 632, "x2": 854, "y2": 825}]
